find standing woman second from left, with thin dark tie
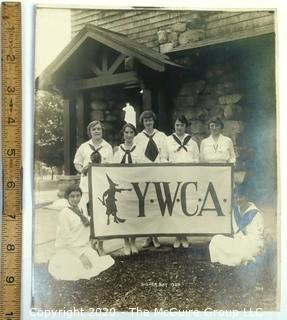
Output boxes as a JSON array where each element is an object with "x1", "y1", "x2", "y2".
[{"x1": 114, "y1": 123, "x2": 139, "y2": 255}]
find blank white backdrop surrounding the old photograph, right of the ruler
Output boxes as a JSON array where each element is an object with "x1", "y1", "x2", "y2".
[{"x1": 22, "y1": 0, "x2": 287, "y2": 320}]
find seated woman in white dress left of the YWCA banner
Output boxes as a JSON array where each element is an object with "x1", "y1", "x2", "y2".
[{"x1": 48, "y1": 186, "x2": 114, "y2": 281}]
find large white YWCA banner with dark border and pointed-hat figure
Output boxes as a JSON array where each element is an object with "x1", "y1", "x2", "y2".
[{"x1": 89, "y1": 164, "x2": 232, "y2": 238}]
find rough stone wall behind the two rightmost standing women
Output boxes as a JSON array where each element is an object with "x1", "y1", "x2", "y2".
[{"x1": 173, "y1": 64, "x2": 244, "y2": 170}]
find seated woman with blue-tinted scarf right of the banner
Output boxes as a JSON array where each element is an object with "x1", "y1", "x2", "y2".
[{"x1": 209, "y1": 186, "x2": 264, "y2": 266}]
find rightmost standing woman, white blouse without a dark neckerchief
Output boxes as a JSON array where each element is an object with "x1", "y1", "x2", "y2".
[{"x1": 200, "y1": 117, "x2": 236, "y2": 163}]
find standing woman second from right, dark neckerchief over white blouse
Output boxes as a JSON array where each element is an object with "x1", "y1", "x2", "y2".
[{"x1": 163, "y1": 115, "x2": 199, "y2": 248}]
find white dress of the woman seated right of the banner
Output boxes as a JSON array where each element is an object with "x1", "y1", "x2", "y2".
[{"x1": 209, "y1": 202, "x2": 264, "y2": 266}]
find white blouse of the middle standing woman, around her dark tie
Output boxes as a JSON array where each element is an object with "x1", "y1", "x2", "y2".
[{"x1": 134, "y1": 129, "x2": 166, "y2": 163}]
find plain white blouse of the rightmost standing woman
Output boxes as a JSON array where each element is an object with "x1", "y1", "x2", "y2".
[{"x1": 200, "y1": 134, "x2": 236, "y2": 163}]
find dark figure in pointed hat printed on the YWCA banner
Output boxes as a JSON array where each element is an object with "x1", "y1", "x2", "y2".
[{"x1": 99, "y1": 174, "x2": 132, "y2": 225}]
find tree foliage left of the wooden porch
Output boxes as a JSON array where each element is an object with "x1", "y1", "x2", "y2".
[{"x1": 35, "y1": 91, "x2": 64, "y2": 169}]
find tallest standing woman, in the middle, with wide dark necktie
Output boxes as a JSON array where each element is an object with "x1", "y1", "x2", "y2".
[{"x1": 134, "y1": 110, "x2": 166, "y2": 248}]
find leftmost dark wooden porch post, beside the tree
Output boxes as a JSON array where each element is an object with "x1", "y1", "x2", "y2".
[{"x1": 64, "y1": 97, "x2": 76, "y2": 175}]
